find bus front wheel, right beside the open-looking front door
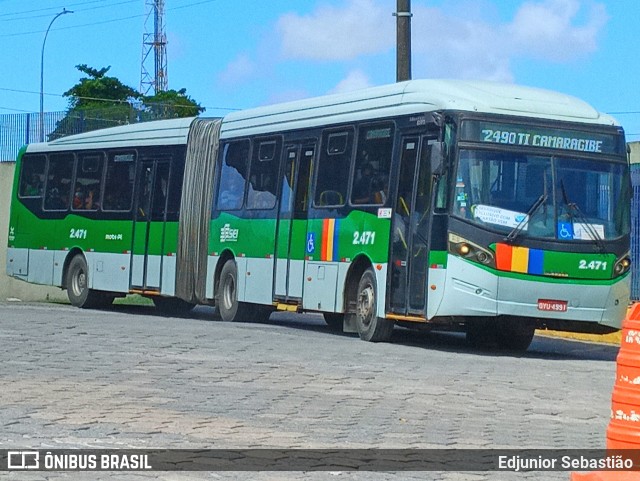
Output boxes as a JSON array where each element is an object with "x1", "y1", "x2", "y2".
[{"x1": 356, "y1": 268, "x2": 394, "y2": 342}]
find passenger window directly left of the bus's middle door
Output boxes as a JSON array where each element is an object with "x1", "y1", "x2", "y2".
[{"x1": 247, "y1": 140, "x2": 280, "y2": 209}]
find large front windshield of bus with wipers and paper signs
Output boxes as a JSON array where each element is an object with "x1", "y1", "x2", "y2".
[{"x1": 453, "y1": 149, "x2": 630, "y2": 241}]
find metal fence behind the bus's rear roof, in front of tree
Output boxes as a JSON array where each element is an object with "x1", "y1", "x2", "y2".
[{"x1": 0, "y1": 109, "x2": 157, "y2": 162}]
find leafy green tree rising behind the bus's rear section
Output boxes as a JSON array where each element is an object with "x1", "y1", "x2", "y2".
[{"x1": 48, "y1": 64, "x2": 205, "y2": 140}]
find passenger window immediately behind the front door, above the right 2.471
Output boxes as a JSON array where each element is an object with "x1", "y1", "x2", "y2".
[{"x1": 351, "y1": 123, "x2": 394, "y2": 205}]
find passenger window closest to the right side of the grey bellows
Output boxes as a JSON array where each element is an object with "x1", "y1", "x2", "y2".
[{"x1": 216, "y1": 140, "x2": 249, "y2": 210}]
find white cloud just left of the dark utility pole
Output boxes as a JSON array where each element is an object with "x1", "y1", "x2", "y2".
[{"x1": 277, "y1": 0, "x2": 395, "y2": 61}]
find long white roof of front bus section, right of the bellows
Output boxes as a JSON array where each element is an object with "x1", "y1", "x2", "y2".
[{"x1": 221, "y1": 80, "x2": 619, "y2": 138}]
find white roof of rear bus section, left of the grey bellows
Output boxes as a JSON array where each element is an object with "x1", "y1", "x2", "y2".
[{"x1": 27, "y1": 117, "x2": 194, "y2": 152}]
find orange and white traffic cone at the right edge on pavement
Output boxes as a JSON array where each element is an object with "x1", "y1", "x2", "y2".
[{"x1": 571, "y1": 304, "x2": 640, "y2": 481}]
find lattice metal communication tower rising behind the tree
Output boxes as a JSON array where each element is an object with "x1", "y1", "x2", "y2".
[{"x1": 140, "y1": 0, "x2": 169, "y2": 95}]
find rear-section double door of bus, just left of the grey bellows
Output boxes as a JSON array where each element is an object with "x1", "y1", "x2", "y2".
[{"x1": 130, "y1": 161, "x2": 169, "y2": 292}]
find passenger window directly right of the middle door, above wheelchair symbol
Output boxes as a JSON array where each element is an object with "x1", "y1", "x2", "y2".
[{"x1": 314, "y1": 130, "x2": 353, "y2": 206}]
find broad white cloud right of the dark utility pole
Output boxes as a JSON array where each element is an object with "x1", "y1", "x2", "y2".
[{"x1": 413, "y1": 0, "x2": 608, "y2": 82}]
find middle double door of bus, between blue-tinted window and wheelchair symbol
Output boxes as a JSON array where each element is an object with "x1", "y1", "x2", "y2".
[{"x1": 274, "y1": 142, "x2": 316, "y2": 303}]
